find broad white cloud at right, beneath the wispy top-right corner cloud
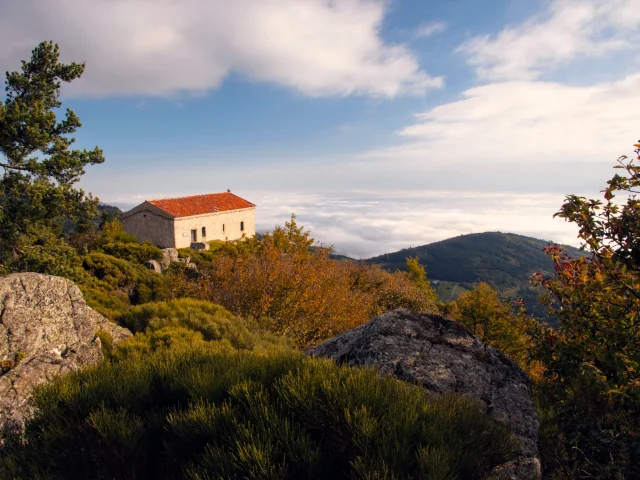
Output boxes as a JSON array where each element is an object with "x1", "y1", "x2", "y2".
[{"x1": 363, "y1": 73, "x2": 640, "y2": 164}]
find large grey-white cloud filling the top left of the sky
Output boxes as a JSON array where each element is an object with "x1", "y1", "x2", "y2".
[{"x1": 0, "y1": 0, "x2": 442, "y2": 97}]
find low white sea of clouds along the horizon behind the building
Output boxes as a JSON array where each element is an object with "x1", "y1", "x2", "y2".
[{"x1": 106, "y1": 191, "x2": 579, "y2": 258}]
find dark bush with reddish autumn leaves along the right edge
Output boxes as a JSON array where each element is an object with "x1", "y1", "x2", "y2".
[{"x1": 533, "y1": 144, "x2": 640, "y2": 480}]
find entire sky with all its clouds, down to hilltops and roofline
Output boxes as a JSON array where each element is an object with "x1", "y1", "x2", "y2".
[{"x1": 0, "y1": 0, "x2": 640, "y2": 257}]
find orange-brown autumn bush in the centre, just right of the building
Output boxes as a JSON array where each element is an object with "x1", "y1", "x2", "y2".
[{"x1": 172, "y1": 217, "x2": 437, "y2": 346}]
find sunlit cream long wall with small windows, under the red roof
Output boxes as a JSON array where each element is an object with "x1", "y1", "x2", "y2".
[{"x1": 173, "y1": 207, "x2": 256, "y2": 248}]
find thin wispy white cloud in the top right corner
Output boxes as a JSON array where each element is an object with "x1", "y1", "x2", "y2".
[{"x1": 459, "y1": 0, "x2": 640, "y2": 80}]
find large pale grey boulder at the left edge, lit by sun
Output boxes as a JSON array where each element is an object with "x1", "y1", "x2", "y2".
[{"x1": 0, "y1": 273, "x2": 131, "y2": 426}]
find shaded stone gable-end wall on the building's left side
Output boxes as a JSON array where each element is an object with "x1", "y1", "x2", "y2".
[{"x1": 122, "y1": 202, "x2": 175, "y2": 248}]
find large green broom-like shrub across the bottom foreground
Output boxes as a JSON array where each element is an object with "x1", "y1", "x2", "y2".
[{"x1": 0, "y1": 342, "x2": 514, "y2": 480}]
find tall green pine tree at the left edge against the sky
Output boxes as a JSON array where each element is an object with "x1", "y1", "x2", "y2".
[{"x1": 0, "y1": 42, "x2": 104, "y2": 263}]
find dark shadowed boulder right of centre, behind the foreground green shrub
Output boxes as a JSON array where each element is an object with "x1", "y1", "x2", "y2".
[{"x1": 308, "y1": 309, "x2": 540, "y2": 479}]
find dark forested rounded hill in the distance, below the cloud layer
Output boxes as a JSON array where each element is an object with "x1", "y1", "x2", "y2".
[{"x1": 366, "y1": 232, "x2": 584, "y2": 322}]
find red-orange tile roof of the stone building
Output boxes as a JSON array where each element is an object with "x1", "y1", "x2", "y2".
[{"x1": 147, "y1": 192, "x2": 255, "y2": 218}]
